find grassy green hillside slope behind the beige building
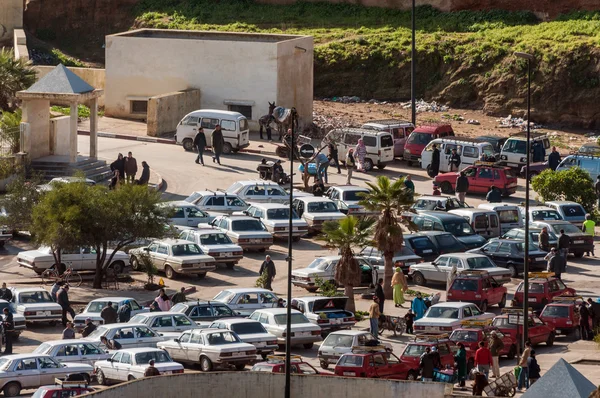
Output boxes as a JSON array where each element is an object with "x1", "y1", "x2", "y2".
[{"x1": 27, "y1": 0, "x2": 600, "y2": 128}]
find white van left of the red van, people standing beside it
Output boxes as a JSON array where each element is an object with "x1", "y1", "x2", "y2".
[{"x1": 321, "y1": 127, "x2": 394, "y2": 171}]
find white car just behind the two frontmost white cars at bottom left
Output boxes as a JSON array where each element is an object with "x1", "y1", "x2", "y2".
[{"x1": 33, "y1": 339, "x2": 110, "y2": 365}]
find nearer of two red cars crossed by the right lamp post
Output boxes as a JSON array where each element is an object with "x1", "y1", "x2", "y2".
[{"x1": 492, "y1": 308, "x2": 556, "y2": 347}]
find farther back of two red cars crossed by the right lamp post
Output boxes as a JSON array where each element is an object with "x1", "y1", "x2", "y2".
[{"x1": 512, "y1": 272, "x2": 577, "y2": 309}]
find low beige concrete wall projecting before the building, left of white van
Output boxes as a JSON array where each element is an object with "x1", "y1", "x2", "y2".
[{"x1": 147, "y1": 89, "x2": 201, "y2": 137}]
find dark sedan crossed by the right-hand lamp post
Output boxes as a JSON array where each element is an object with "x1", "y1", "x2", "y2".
[{"x1": 467, "y1": 239, "x2": 548, "y2": 278}]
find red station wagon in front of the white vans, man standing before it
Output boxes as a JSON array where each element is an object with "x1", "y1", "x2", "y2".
[{"x1": 433, "y1": 162, "x2": 517, "y2": 196}]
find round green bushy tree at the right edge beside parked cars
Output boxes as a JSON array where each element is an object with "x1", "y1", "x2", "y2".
[{"x1": 531, "y1": 167, "x2": 597, "y2": 213}]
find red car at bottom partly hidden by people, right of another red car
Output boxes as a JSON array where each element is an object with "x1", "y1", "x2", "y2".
[{"x1": 400, "y1": 334, "x2": 454, "y2": 380}]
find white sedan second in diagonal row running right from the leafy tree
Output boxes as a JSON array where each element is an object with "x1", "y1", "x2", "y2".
[{"x1": 179, "y1": 228, "x2": 244, "y2": 269}]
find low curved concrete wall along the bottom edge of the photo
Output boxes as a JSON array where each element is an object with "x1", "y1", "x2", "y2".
[{"x1": 83, "y1": 372, "x2": 452, "y2": 398}]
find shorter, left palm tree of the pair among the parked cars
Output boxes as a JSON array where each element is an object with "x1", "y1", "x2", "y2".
[{"x1": 318, "y1": 216, "x2": 375, "y2": 312}]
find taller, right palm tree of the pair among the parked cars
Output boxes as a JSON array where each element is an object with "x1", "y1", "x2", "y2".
[{"x1": 359, "y1": 176, "x2": 414, "y2": 299}]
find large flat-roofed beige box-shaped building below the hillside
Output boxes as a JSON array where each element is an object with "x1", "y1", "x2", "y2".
[{"x1": 105, "y1": 29, "x2": 313, "y2": 131}]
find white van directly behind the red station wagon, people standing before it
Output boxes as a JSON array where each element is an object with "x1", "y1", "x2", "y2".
[{"x1": 421, "y1": 137, "x2": 496, "y2": 173}]
